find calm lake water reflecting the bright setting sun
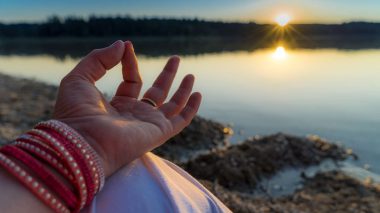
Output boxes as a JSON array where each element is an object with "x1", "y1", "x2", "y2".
[{"x1": 0, "y1": 41, "x2": 380, "y2": 173}]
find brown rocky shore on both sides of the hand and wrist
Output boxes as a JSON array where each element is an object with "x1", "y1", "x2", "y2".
[{"x1": 0, "y1": 74, "x2": 380, "y2": 212}]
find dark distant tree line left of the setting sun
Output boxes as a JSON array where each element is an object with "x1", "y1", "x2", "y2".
[{"x1": 0, "y1": 16, "x2": 266, "y2": 37}]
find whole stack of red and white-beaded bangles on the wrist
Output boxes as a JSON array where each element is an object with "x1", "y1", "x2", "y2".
[{"x1": 0, "y1": 120, "x2": 105, "y2": 213}]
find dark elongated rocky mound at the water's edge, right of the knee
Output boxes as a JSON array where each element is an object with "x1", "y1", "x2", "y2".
[{"x1": 181, "y1": 133, "x2": 348, "y2": 192}]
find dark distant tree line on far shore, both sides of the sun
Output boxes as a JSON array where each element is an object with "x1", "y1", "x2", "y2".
[{"x1": 0, "y1": 16, "x2": 380, "y2": 38}]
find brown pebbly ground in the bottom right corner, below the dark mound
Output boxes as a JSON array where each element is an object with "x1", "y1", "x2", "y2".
[{"x1": 201, "y1": 171, "x2": 380, "y2": 213}]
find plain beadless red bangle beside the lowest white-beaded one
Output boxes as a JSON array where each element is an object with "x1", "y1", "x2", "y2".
[{"x1": 0, "y1": 145, "x2": 77, "y2": 209}]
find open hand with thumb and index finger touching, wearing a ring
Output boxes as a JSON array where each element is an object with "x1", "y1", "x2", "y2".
[{"x1": 54, "y1": 41, "x2": 201, "y2": 176}]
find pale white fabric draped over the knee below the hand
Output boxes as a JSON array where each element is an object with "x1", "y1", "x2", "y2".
[{"x1": 84, "y1": 153, "x2": 231, "y2": 213}]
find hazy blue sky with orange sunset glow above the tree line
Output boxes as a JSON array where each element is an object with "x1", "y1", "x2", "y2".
[{"x1": 0, "y1": 0, "x2": 380, "y2": 23}]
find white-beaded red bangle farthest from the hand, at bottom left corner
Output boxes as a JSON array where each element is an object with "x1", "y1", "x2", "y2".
[{"x1": 0, "y1": 153, "x2": 70, "y2": 213}]
